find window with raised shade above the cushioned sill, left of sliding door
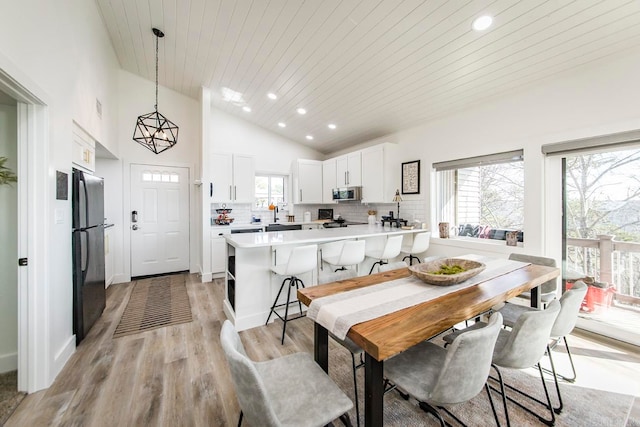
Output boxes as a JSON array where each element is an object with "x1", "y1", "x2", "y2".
[{"x1": 433, "y1": 150, "x2": 524, "y2": 241}]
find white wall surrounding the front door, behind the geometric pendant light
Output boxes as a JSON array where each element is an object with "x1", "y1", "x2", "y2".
[{"x1": 105, "y1": 70, "x2": 201, "y2": 283}]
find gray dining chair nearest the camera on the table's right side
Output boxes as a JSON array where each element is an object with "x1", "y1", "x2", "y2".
[{"x1": 384, "y1": 313, "x2": 502, "y2": 426}]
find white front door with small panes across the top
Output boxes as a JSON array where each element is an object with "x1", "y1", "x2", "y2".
[{"x1": 130, "y1": 164, "x2": 189, "y2": 277}]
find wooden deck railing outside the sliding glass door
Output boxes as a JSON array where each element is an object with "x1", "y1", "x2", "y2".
[{"x1": 567, "y1": 234, "x2": 640, "y2": 305}]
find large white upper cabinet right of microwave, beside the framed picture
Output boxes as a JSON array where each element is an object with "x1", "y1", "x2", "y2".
[{"x1": 361, "y1": 143, "x2": 400, "y2": 203}]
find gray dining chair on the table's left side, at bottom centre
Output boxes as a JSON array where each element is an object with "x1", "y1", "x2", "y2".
[{"x1": 220, "y1": 320, "x2": 353, "y2": 427}]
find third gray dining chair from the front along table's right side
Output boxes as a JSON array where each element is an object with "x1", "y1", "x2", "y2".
[{"x1": 499, "y1": 281, "x2": 587, "y2": 414}]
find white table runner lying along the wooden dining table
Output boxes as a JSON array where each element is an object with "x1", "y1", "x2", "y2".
[{"x1": 307, "y1": 254, "x2": 529, "y2": 339}]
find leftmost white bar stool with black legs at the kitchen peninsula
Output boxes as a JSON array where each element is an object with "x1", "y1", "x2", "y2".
[{"x1": 265, "y1": 245, "x2": 318, "y2": 344}]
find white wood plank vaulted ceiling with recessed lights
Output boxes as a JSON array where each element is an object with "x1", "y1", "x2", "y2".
[{"x1": 96, "y1": 0, "x2": 640, "y2": 153}]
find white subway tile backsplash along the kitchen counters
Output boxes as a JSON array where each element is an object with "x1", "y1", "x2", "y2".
[{"x1": 211, "y1": 200, "x2": 427, "y2": 224}]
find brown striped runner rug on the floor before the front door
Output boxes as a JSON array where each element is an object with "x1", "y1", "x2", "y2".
[{"x1": 113, "y1": 274, "x2": 192, "y2": 338}]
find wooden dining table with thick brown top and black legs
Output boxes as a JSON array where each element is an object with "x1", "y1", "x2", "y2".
[{"x1": 298, "y1": 264, "x2": 560, "y2": 426}]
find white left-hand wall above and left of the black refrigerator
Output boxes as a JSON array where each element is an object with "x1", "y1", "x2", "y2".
[{"x1": 0, "y1": 0, "x2": 119, "y2": 391}]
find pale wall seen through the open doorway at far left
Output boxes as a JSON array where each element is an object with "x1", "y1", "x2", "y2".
[{"x1": 0, "y1": 104, "x2": 18, "y2": 373}]
